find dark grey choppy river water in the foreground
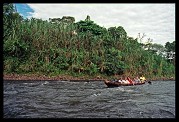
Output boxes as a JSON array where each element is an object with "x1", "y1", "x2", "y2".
[{"x1": 3, "y1": 81, "x2": 176, "y2": 118}]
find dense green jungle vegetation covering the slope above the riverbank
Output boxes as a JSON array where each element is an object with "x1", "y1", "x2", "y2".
[{"x1": 3, "y1": 4, "x2": 175, "y2": 78}]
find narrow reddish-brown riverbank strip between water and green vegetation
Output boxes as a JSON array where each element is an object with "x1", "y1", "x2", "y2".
[{"x1": 3, "y1": 74, "x2": 175, "y2": 81}]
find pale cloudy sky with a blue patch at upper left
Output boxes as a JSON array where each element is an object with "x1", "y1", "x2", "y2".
[{"x1": 15, "y1": 3, "x2": 175, "y2": 46}]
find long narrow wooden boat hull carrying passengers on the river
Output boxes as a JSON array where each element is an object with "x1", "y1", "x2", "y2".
[{"x1": 104, "y1": 80, "x2": 145, "y2": 87}]
